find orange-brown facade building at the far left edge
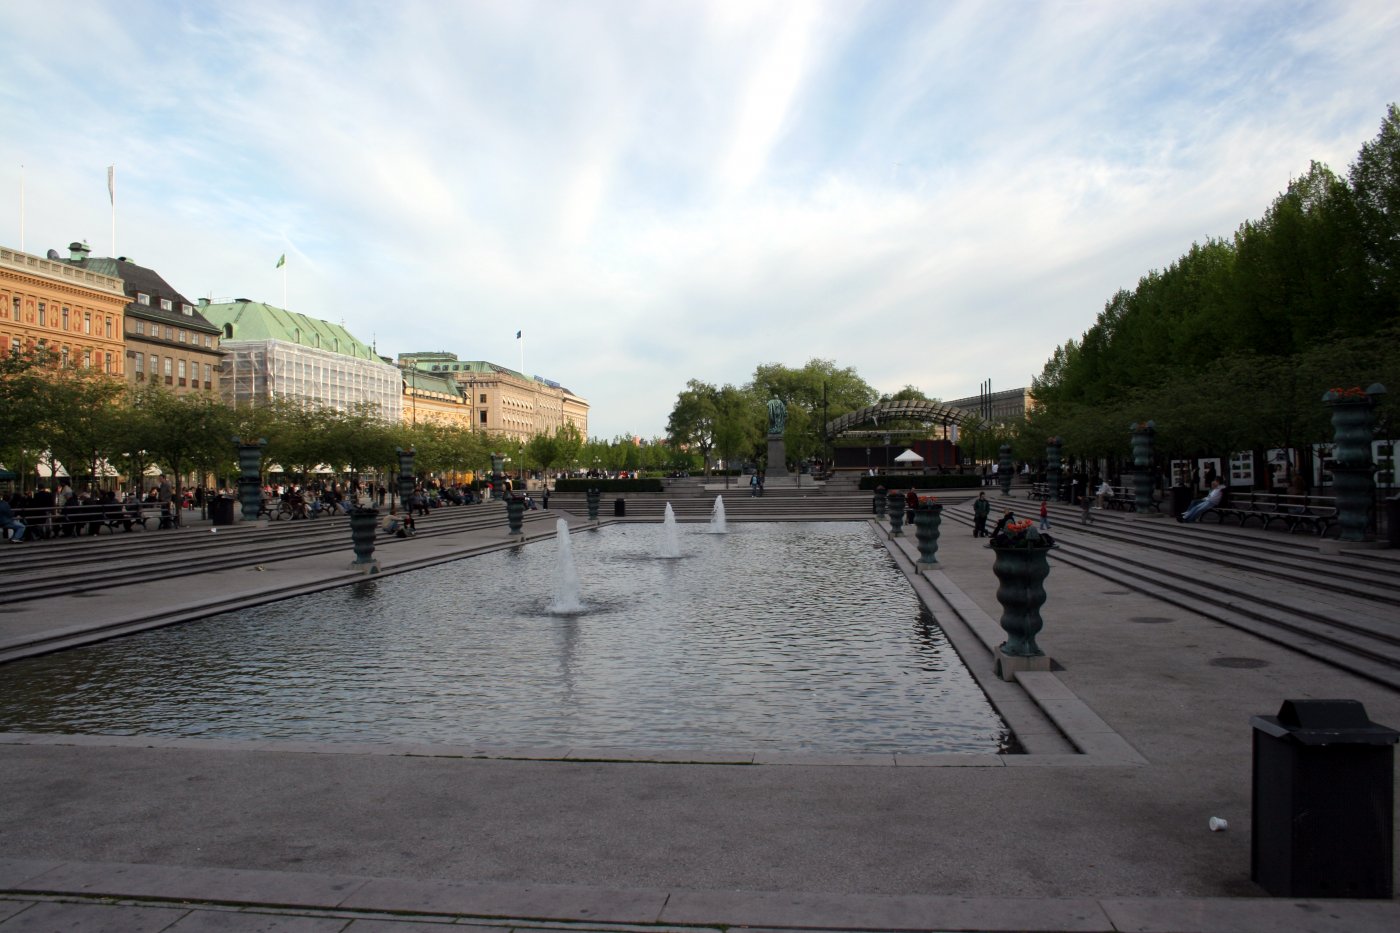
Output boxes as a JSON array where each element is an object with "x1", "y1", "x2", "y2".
[{"x1": 0, "y1": 240, "x2": 127, "y2": 375}]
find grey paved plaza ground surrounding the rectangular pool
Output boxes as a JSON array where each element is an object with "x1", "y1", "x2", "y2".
[{"x1": 0, "y1": 493, "x2": 1400, "y2": 933}]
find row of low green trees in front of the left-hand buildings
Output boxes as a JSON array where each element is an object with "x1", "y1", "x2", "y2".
[{"x1": 0, "y1": 352, "x2": 675, "y2": 485}]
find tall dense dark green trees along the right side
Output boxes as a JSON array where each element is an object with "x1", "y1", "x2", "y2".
[{"x1": 1022, "y1": 105, "x2": 1400, "y2": 455}]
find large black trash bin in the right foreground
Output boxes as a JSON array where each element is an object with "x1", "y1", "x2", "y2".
[{"x1": 1249, "y1": 699, "x2": 1400, "y2": 898}]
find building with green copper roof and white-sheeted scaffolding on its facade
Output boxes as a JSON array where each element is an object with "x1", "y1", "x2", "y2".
[{"x1": 199, "y1": 298, "x2": 403, "y2": 422}]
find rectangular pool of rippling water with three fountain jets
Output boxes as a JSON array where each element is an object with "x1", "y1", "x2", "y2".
[{"x1": 0, "y1": 523, "x2": 1012, "y2": 754}]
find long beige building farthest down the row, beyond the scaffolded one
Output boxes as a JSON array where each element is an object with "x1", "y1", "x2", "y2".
[{"x1": 398, "y1": 353, "x2": 588, "y2": 441}]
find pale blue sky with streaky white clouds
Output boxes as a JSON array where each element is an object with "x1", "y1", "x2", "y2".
[{"x1": 0, "y1": 0, "x2": 1400, "y2": 438}]
